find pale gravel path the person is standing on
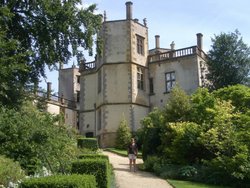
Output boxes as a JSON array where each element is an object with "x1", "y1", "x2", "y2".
[{"x1": 103, "y1": 151, "x2": 172, "y2": 188}]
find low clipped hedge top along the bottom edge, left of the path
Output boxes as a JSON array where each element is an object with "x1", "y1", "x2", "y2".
[{"x1": 20, "y1": 174, "x2": 97, "y2": 188}]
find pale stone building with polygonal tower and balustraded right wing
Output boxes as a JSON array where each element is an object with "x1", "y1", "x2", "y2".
[{"x1": 74, "y1": 2, "x2": 205, "y2": 147}]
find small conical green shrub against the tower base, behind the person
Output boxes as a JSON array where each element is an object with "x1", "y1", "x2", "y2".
[{"x1": 115, "y1": 118, "x2": 132, "y2": 149}]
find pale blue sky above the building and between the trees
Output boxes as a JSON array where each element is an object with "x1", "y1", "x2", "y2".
[{"x1": 40, "y1": 0, "x2": 250, "y2": 92}]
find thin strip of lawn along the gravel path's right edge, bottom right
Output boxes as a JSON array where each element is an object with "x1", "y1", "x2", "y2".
[{"x1": 167, "y1": 179, "x2": 229, "y2": 188}]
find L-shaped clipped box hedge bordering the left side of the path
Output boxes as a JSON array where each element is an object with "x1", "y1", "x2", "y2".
[{"x1": 72, "y1": 158, "x2": 111, "y2": 188}]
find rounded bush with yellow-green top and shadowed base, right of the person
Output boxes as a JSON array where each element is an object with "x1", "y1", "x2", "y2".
[{"x1": 161, "y1": 122, "x2": 207, "y2": 165}]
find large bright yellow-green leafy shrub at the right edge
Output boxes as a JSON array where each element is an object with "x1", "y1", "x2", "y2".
[{"x1": 200, "y1": 101, "x2": 250, "y2": 181}]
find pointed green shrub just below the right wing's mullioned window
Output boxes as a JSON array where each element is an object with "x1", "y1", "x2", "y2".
[{"x1": 164, "y1": 86, "x2": 191, "y2": 122}]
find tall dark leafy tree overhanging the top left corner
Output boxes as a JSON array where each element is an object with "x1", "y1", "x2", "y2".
[{"x1": 0, "y1": 0, "x2": 102, "y2": 107}]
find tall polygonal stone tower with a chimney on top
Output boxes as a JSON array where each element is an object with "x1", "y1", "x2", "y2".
[{"x1": 80, "y1": 2, "x2": 149, "y2": 147}]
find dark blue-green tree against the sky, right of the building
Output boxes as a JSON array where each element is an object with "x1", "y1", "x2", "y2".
[{"x1": 207, "y1": 30, "x2": 250, "y2": 89}]
